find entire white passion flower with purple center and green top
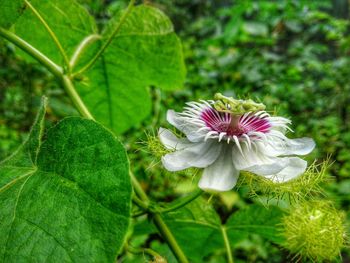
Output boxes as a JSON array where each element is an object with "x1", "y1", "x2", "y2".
[{"x1": 159, "y1": 94, "x2": 315, "y2": 191}]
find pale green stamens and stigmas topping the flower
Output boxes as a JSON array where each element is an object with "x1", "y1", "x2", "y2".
[{"x1": 214, "y1": 93, "x2": 266, "y2": 115}]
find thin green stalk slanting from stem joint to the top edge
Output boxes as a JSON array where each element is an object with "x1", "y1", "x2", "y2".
[{"x1": 73, "y1": 0, "x2": 136, "y2": 76}]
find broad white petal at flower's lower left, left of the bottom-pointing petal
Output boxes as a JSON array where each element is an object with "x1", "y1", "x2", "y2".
[{"x1": 162, "y1": 140, "x2": 222, "y2": 172}]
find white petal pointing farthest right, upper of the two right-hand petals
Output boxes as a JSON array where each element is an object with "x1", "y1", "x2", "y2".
[{"x1": 266, "y1": 138, "x2": 315, "y2": 156}]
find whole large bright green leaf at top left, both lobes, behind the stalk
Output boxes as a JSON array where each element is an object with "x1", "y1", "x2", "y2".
[{"x1": 15, "y1": 0, "x2": 185, "y2": 133}]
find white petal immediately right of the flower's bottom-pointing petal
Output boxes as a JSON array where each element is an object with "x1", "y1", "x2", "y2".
[{"x1": 232, "y1": 141, "x2": 275, "y2": 170}]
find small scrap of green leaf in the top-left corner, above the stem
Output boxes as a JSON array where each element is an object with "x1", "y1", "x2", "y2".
[{"x1": 0, "y1": 0, "x2": 25, "y2": 28}]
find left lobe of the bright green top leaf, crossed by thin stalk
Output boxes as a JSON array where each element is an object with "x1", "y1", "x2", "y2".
[{"x1": 15, "y1": 0, "x2": 97, "y2": 65}]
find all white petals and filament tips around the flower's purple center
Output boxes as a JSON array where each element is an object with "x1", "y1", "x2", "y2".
[{"x1": 159, "y1": 101, "x2": 315, "y2": 191}]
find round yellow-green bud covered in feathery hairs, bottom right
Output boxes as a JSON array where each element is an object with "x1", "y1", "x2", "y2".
[{"x1": 283, "y1": 200, "x2": 346, "y2": 262}]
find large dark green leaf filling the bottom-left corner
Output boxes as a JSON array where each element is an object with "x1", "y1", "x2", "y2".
[{"x1": 0, "y1": 98, "x2": 131, "y2": 262}]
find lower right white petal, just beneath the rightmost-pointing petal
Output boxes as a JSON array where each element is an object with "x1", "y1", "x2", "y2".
[{"x1": 265, "y1": 157, "x2": 307, "y2": 183}]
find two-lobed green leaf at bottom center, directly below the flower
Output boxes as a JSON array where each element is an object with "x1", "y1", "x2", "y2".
[{"x1": 165, "y1": 200, "x2": 283, "y2": 262}]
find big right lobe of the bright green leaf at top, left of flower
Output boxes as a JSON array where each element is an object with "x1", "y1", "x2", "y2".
[{"x1": 78, "y1": 6, "x2": 185, "y2": 133}]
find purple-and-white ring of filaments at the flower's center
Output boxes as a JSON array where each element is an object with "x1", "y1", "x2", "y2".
[{"x1": 201, "y1": 108, "x2": 271, "y2": 137}]
